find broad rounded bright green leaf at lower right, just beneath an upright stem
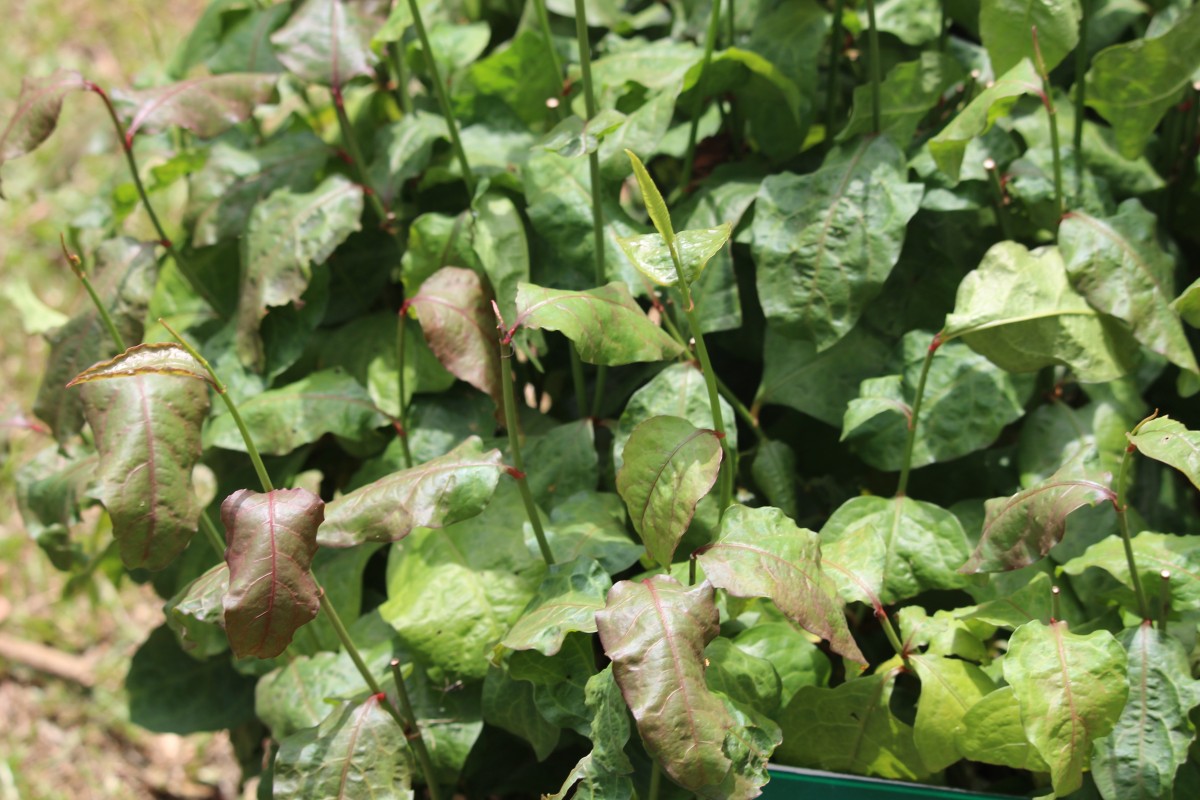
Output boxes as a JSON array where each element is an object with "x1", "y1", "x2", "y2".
[{"x1": 821, "y1": 497, "x2": 968, "y2": 606}]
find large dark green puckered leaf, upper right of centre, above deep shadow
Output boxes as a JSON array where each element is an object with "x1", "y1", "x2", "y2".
[{"x1": 751, "y1": 137, "x2": 924, "y2": 351}]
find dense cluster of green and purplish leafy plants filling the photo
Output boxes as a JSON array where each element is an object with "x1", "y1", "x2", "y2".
[{"x1": 0, "y1": 0, "x2": 1200, "y2": 800}]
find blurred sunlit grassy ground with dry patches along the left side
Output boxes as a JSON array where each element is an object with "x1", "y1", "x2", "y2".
[{"x1": 0, "y1": 0, "x2": 248, "y2": 800}]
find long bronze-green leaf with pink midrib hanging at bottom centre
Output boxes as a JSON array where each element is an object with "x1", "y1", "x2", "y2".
[{"x1": 596, "y1": 576, "x2": 757, "y2": 799}]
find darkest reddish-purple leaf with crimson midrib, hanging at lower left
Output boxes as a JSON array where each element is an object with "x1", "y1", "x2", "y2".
[{"x1": 221, "y1": 489, "x2": 325, "y2": 658}]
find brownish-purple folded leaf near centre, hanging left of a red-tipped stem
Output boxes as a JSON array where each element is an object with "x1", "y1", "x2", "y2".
[{"x1": 408, "y1": 266, "x2": 503, "y2": 405}]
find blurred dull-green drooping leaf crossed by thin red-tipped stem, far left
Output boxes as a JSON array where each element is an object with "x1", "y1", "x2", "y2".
[{"x1": 34, "y1": 237, "x2": 158, "y2": 443}]
